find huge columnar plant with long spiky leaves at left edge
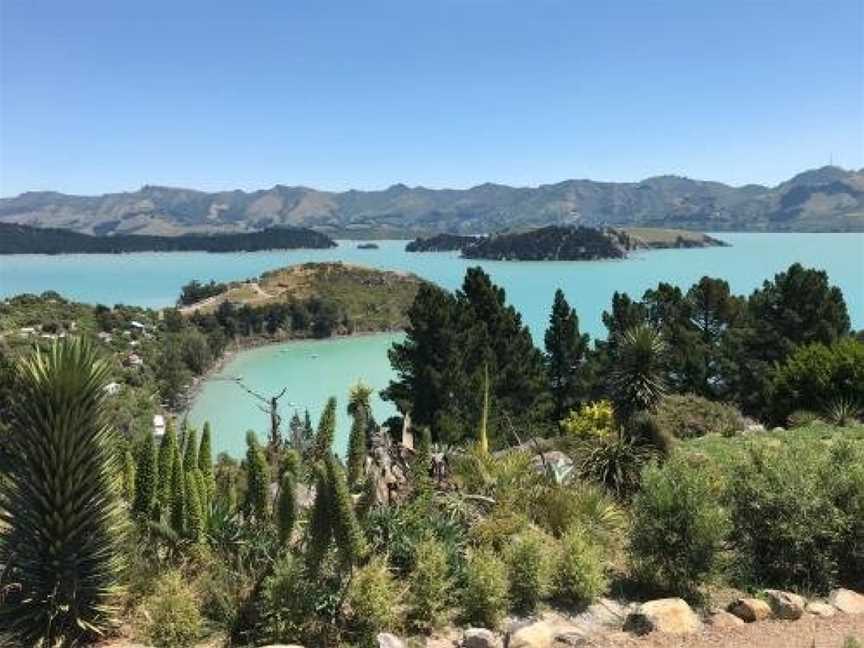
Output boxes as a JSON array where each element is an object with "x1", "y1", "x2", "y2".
[{"x1": 0, "y1": 340, "x2": 126, "y2": 646}]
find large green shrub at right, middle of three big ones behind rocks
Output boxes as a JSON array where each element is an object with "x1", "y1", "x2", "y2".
[{"x1": 729, "y1": 446, "x2": 843, "y2": 591}]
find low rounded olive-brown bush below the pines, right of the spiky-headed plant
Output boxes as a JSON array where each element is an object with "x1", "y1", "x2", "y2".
[{"x1": 654, "y1": 394, "x2": 744, "y2": 439}]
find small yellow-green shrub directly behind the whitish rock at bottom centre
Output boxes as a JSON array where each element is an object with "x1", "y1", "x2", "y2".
[{"x1": 462, "y1": 548, "x2": 509, "y2": 628}]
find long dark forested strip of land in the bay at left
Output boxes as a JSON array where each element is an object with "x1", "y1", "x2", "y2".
[{"x1": 0, "y1": 223, "x2": 336, "y2": 254}]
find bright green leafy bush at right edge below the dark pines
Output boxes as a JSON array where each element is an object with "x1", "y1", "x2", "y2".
[{"x1": 771, "y1": 337, "x2": 864, "y2": 421}]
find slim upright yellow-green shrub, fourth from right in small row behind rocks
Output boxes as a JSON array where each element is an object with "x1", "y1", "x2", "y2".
[{"x1": 408, "y1": 534, "x2": 451, "y2": 630}]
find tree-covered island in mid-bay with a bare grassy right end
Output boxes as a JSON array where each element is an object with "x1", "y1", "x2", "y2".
[{"x1": 405, "y1": 225, "x2": 728, "y2": 261}]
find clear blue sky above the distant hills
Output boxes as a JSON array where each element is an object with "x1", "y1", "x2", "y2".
[{"x1": 0, "y1": 0, "x2": 864, "y2": 196}]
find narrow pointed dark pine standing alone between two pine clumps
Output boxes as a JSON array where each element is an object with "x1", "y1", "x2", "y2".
[{"x1": 544, "y1": 288, "x2": 588, "y2": 422}]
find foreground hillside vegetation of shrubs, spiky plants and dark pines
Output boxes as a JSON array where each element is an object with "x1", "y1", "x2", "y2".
[{"x1": 0, "y1": 265, "x2": 864, "y2": 647}]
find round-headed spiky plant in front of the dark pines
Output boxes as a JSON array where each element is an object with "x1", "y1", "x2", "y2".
[{"x1": 610, "y1": 324, "x2": 666, "y2": 423}]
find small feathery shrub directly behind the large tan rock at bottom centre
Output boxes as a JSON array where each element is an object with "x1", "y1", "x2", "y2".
[{"x1": 505, "y1": 529, "x2": 554, "y2": 614}]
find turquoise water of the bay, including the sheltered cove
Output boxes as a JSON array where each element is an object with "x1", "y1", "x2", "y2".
[{"x1": 0, "y1": 233, "x2": 864, "y2": 455}]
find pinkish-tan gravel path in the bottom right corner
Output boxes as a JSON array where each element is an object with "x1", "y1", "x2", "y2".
[{"x1": 587, "y1": 614, "x2": 864, "y2": 648}]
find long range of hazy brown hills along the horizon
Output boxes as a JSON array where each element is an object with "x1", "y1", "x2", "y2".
[{"x1": 0, "y1": 167, "x2": 864, "y2": 238}]
